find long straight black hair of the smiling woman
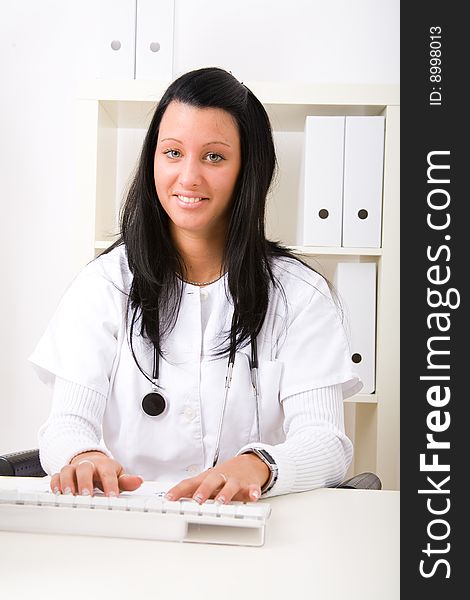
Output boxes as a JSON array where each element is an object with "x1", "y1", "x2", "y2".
[{"x1": 106, "y1": 67, "x2": 314, "y2": 372}]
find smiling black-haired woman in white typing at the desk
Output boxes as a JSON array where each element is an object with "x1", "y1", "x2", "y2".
[{"x1": 31, "y1": 68, "x2": 361, "y2": 503}]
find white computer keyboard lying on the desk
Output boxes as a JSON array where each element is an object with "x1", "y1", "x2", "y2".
[{"x1": 0, "y1": 490, "x2": 271, "y2": 546}]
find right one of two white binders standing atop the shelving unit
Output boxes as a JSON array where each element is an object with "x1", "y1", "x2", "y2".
[{"x1": 135, "y1": 0, "x2": 175, "y2": 81}]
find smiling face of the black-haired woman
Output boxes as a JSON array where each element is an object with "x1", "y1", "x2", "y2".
[{"x1": 154, "y1": 102, "x2": 241, "y2": 242}]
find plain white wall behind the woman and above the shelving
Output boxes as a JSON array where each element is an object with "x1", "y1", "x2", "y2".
[{"x1": 0, "y1": 0, "x2": 399, "y2": 452}]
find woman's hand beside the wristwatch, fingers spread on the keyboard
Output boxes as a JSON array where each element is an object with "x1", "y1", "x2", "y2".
[{"x1": 165, "y1": 454, "x2": 270, "y2": 504}]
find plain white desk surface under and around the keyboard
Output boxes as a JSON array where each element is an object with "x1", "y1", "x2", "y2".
[{"x1": 0, "y1": 477, "x2": 400, "y2": 600}]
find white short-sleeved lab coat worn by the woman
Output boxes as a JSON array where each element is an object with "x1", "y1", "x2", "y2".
[{"x1": 30, "y1": 246, "x2": 362, "y2": 481}]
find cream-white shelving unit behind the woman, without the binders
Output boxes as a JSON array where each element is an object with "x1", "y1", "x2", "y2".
[{"x1": 76, "y1": 80, "x2": 400, "y2": 489}]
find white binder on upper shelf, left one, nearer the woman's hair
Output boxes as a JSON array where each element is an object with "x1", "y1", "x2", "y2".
[{"x1": 300, "y1": 116, "x2": 345, "y2": 246}]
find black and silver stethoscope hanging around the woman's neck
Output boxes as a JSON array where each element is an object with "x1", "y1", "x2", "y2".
[{"x1": 142, "y1": 336, "x2": 261, "y2": 467}]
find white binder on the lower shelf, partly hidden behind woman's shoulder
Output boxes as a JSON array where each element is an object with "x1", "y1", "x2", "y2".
[{"x1": 334, "y1": 262, "x2": 376, "y2": 394}]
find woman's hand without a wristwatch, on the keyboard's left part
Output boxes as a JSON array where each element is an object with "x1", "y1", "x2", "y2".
[{"x1": 51, "y1": 451, "x2": 144, "y2": 496}]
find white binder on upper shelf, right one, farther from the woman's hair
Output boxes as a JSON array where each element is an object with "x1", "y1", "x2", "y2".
[{"x1": 342, "y1": 116, "x2": 385, "y2": 248}]
